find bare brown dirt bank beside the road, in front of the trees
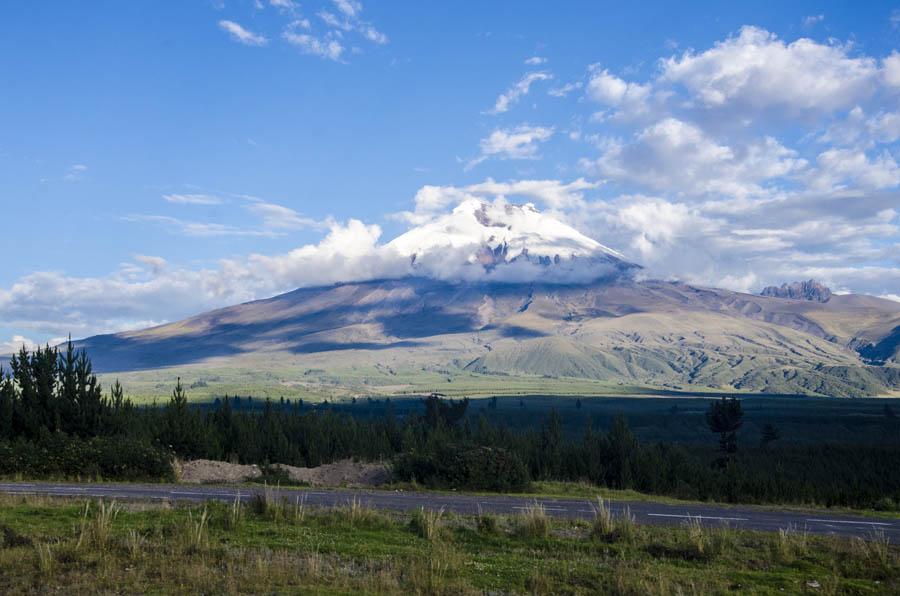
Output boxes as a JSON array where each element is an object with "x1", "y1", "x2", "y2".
[{"x1": 176, "y1": 459, "x2": 391, "y2": 486}]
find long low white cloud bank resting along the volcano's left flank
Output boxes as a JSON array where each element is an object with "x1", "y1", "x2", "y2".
[{"x1": 0, "y1": 220, "x2": 409, "y2": 337}]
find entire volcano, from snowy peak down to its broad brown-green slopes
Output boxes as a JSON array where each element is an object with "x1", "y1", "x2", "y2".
[{"x1": 68, "y1": 201, "x2": 900, "y2": 396}]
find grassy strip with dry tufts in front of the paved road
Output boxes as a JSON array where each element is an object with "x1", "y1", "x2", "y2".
[{"x1": 0, "y1": 496, "x2": 900, "y2": 594}]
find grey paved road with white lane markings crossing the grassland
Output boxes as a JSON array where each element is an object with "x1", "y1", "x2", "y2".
[{"x1": 0, "y1": 482, "x2": 900, "y2": 544}]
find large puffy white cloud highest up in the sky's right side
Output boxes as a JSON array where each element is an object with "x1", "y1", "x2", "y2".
[{"x1": 662, "y1": 27, "x2": 878, "y2": 112}]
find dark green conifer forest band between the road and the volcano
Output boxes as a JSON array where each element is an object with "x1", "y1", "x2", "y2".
[{"x1": 0, "y1": 343, "x2": 900, "y2": 510}]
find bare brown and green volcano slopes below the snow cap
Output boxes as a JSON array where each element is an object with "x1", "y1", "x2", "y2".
[{"x1": 82, "y1": 277, "x2": 900, "y2": 396}]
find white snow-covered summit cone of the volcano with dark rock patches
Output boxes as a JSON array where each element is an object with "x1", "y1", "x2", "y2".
[{"x1": 388, "y1": 199, "x2": 638, "y2": 281}]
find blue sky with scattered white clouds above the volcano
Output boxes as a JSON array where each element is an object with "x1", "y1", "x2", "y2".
[{"x1": 0, "y1": 0, "x2": 900, "y2": 352}]
